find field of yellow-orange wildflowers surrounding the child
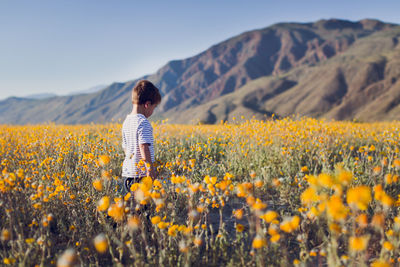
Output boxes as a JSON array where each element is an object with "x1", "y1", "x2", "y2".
[{"x1": 0, "y1": 118, "x2": 400, "y2": 266}]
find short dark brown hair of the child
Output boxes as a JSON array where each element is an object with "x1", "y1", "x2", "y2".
[{"x1": 132, "y1": 80, "x2": 161, "y2": 105}]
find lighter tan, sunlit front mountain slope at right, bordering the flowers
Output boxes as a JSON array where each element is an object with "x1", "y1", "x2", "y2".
[{"x1": 165, "y1": 27, "x2": 400, "y2": 123}]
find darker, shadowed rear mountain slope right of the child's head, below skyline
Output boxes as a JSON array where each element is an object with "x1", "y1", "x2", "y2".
[{"x1": 149, "y1": 20, "x2": 393, "y2": 114}]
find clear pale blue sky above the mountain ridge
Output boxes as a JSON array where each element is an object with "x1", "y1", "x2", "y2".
[{"x1": 0, "y1": 0, "x2": 400, "y2": 99}]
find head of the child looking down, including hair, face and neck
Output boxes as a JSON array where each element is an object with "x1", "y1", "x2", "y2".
[{"x1": 132, "y1": 80, "x2": 161, "y2": 117}]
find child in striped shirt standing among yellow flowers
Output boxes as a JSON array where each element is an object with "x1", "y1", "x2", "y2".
[{"x1": 122, "y1": 80, "x2": 161, "y2": 194}]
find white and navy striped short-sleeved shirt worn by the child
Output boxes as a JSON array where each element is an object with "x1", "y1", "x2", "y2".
[{"x1": 122, "y1": 114, "x2": 154, "y2": 177}]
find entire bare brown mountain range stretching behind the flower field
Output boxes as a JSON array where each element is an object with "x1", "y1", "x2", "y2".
[{"x1": 0, "y1": 19, "x2": 400, "y2": 124}]
